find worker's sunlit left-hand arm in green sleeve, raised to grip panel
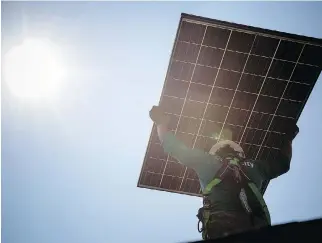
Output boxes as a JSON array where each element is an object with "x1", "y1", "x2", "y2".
[{"x1": 150, "y1": 106, "x2": 220, "y2": 173}]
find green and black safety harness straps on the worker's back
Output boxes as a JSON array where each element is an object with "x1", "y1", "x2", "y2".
[{"x1": 197, "y1": 155, "x2": 271, "y2": 240}]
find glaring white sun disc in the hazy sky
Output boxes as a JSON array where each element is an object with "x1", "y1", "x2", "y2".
[{"x1": 4, "y1": 39, "x2": 63, "y2": 98}]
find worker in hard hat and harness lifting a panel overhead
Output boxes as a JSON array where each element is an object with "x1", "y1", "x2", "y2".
[{"x1": 150, "y1": 106, "x2": 299, "y2": 239}]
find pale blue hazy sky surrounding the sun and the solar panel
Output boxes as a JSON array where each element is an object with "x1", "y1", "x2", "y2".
[{"x1": 1, "y1": 2, "x2": 322, "y2": 243}]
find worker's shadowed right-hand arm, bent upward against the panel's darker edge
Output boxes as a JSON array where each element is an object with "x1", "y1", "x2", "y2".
[{"x1": 255, "y1": 124, "x2": 299, "y2": 180}]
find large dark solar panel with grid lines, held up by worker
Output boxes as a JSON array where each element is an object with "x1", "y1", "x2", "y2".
[{"x1": 138, "y1": 14, "x2": 322, "y2": 196}]
